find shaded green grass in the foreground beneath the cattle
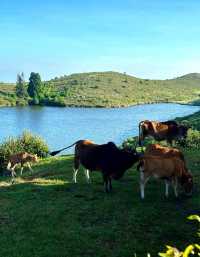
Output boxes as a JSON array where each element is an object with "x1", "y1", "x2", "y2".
[{"x1": 0, "y1": 151, "x2": 200, "y2": 257}]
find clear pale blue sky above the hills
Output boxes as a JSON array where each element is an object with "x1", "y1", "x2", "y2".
[{"x1": 0, "y1": 0, "x2": 200, "y2": 82}]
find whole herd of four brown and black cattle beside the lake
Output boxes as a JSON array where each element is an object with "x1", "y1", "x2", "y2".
[{"x1": 7, "y1": 120, "x2": 193, "y2": 199}]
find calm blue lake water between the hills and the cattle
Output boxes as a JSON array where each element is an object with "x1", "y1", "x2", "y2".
[{"x1": 0, "y1": 104, "x2": 200, "y2": 153}]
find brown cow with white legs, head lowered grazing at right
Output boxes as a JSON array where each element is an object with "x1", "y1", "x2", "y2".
[{"x1": 137, "y1": 154, "x2": 193, "y2": 199}]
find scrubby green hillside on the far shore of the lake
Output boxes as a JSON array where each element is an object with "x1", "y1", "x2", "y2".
[{"x1": 0, "y1": 72, "x2": 200, "y2": 107}]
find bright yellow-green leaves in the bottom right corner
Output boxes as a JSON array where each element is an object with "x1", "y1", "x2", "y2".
[{"x1": 159, "y1": 215, "x2": 200, "y2": 257}]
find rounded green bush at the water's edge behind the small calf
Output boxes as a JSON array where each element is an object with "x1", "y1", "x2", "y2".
[{"x1": 0, "y1": 131, "x2": 49, "y2": 172}]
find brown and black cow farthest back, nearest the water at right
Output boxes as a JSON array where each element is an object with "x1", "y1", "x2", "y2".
[{"x1": 139, "y1": 120, "x2": 188, "y2": 146}]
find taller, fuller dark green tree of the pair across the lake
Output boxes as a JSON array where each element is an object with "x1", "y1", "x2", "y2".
[{"x1": 28, "y1": 72, "x2": 42, "y2": 101}]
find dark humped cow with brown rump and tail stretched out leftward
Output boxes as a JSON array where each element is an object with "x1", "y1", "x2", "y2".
[{"x1": 51, "y1": 140, "x2": 139, "y2": 192}]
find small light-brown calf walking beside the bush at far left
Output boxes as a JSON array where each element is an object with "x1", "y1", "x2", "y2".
[{"x1": 7, "y1": 152, "x2": 38, "y2": 177}]
